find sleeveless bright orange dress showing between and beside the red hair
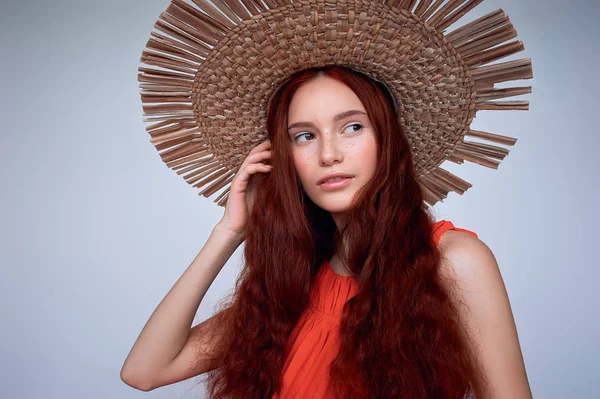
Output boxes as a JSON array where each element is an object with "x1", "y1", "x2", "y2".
[{"x1": 272, "y1": 220, "x2": 477, "y2": 399}]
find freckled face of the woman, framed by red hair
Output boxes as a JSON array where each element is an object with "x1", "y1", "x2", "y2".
[{"x1": 288, "y1": 76, "x2": 377, "y2": 224}]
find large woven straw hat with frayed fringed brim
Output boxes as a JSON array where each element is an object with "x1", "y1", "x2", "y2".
[{"x1": 138, "y1": 0, "x2": 533, "y2": 206}]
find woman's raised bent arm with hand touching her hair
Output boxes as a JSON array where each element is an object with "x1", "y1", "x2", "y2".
[{"x1": 121, "y1": 140, "x2": 271, "y2": 391}]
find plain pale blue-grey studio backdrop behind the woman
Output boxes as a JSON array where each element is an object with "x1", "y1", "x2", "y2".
[{"x1": 0, "y1": 0, "x2": 600, "y2": 399}]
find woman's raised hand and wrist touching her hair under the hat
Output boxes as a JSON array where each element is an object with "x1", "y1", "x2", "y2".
[{"x1": 219, "y1": 139, "x2": 272, "y2": 240}]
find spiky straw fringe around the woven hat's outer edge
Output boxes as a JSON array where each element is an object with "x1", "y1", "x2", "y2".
[{"x1": 138, "y1": 0, "x2": 533, "y2": 206}]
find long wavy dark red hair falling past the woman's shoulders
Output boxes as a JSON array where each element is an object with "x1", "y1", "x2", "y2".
[{"x1": 197, "y1": 66, "x2": 482, "y2": 399}]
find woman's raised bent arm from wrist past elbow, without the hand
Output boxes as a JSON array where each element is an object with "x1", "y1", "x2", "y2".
[{"x1": 121, "y1": 224, "x2": 243, "y2": 391}]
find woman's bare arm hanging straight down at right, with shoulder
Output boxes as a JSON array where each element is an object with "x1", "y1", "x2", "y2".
[{"x1": 440, "y1": 231, "x2": 532, "y2": 399}]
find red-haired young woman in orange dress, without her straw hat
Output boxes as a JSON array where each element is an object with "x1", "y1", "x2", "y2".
[{"x1": 121, "y1": 66, "x2": 531, "y2": 399}]
